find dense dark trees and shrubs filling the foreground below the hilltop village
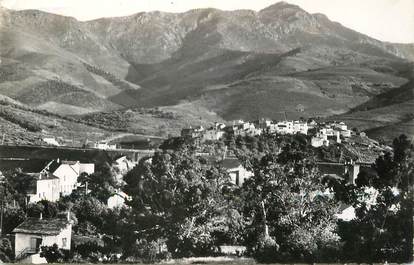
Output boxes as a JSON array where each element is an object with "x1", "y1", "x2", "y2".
[{"x1": 0, "y1": 135, "x2": 414, "y2": 262}]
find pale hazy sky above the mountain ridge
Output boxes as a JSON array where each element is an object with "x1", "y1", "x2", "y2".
[{"x1": 0, "y1": 0, "x2": 414, "y2": 43}]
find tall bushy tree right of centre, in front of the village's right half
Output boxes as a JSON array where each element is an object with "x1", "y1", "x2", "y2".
[{"x1": 239, "y1": 138, "x2": 339, "y2": 262}]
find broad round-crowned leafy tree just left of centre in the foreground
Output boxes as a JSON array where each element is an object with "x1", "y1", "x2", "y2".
[{"x1": 124, "y1": 145, "x2": 233, "y2": 256}]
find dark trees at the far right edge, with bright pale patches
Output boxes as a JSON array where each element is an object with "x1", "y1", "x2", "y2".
[{"x1": 334, "y1": 135, "x2": 414, "y2": 262}]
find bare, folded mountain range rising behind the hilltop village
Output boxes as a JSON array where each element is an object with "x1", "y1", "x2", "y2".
[{"x1": 0, "y1": 2, "x2": 414, "y2": 142}]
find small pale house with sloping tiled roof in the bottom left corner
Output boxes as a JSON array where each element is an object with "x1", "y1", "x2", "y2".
[{"x1": 13, "y1": 213, "x2": 72, "y2": 263}]
